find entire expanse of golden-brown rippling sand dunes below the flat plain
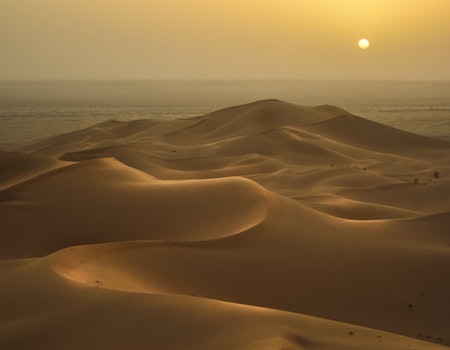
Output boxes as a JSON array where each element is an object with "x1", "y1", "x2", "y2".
[{"x1": 0, "y1": 100, "x2": 450, "y2": 350}]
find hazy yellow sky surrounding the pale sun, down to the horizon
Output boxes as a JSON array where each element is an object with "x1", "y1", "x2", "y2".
[{"x1": 0, "y1": 0, "x2": 450, "y2": 80}]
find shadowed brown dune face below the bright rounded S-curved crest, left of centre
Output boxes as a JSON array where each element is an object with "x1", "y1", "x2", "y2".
[{"x1": 1, "y1": 158, "x2": 267, "y2": 257}]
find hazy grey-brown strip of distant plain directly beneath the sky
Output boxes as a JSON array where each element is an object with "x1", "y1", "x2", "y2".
[{"x1": 0, "y1": 79, "x2": 450, "y2": 106}]
